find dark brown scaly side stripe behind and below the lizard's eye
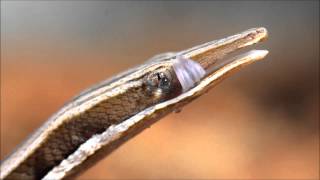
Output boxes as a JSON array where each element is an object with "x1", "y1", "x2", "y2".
[{"x1": 7, "y1": 69, "x2": 181, "y2": 179}]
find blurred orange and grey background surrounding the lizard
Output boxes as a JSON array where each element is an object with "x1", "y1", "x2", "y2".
[{"x1": 1, "y1": 1, "x2": 319, "y2": 179}]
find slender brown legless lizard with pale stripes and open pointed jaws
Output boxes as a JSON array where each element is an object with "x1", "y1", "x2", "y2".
[{"x1": 0, "y1": 27, "x2": 268, "y2": 179}]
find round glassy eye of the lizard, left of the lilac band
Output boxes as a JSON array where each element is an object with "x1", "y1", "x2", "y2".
[{"x1": 147, "y1": 71, "x2": 172, "y2": 91}]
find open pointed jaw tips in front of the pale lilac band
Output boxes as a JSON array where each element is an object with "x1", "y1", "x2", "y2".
[{"x1": 179, "y1": 27, "x2": 268, "y2": 75}]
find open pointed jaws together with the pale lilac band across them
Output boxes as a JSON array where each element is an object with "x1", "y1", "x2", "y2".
[{"x1": 173, "y1": 28, "x2": 268, "y2": 92}]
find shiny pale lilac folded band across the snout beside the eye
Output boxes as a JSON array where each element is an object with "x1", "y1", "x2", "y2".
[{"x1": 173, "y1": 55, "x2": 206, "y2": 92}]
